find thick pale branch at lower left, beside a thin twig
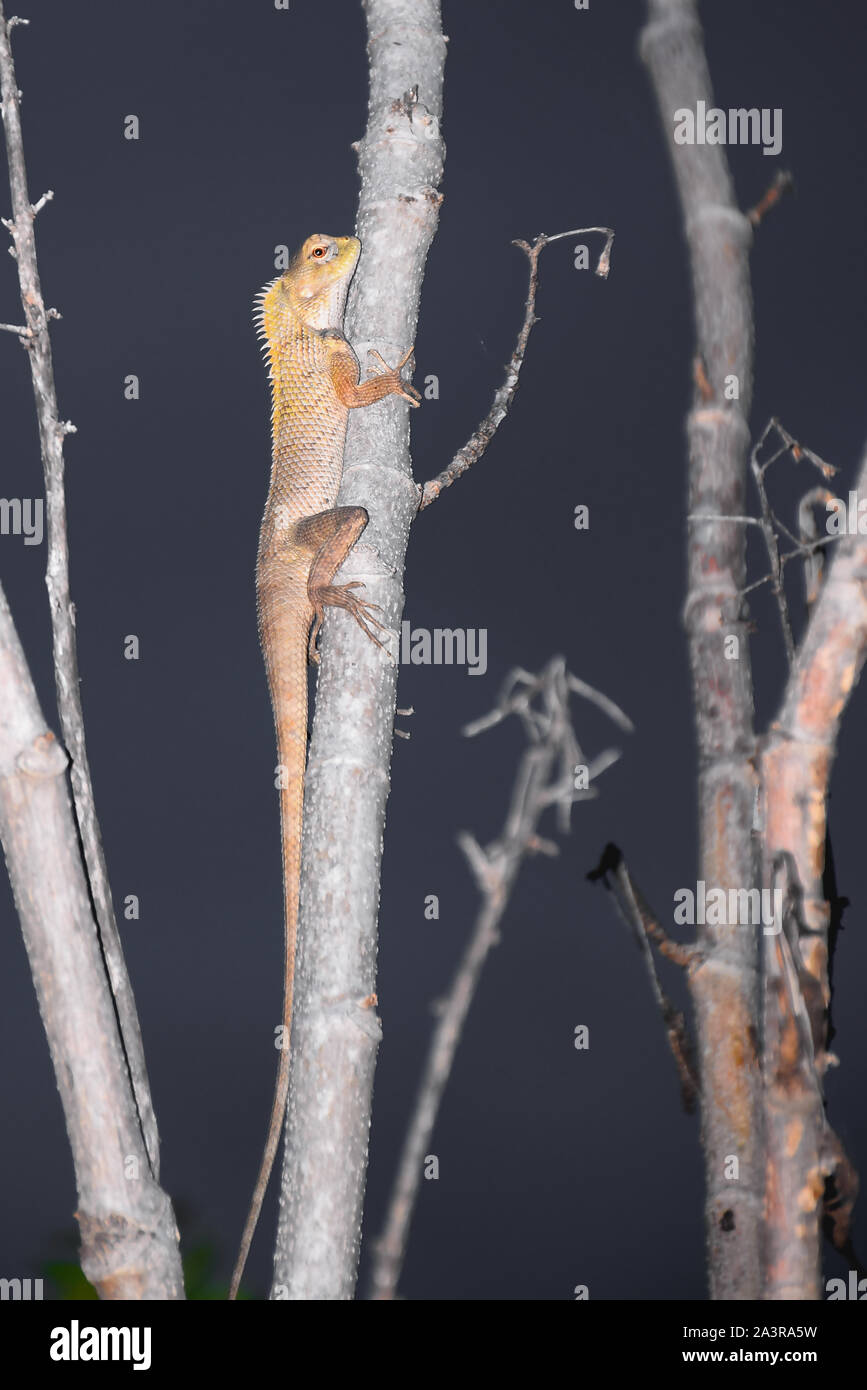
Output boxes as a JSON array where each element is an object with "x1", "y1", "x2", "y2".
[{"x1": 0, "y1": 589, "x2": 183, "y2": 1300}]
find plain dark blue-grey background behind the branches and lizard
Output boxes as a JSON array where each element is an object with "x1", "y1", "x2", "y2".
[{"x1": 0, "y1": 0, "x2": 867, "y2": 1300}]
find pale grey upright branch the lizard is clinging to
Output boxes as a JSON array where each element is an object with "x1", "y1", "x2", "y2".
[{"x1": 272, "y1": 0, "x2": 445, "y2": 1300}]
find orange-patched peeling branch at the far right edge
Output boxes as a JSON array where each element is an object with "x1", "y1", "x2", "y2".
[{"x1": 761, "y1": 442, "x2": 867, "y2": 1300}]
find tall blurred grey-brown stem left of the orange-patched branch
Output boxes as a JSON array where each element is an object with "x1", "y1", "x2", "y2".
[{"x1": 642, "y1": 0, "x2": 763, "y2": 1298}]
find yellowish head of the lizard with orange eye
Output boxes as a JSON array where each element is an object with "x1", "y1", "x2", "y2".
[{"x1": 260, "y1": 234, "x2": 361, "y2": 342}]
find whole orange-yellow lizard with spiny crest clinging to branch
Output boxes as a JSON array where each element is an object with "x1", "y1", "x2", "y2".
[{"x1": 229, "y1": 235, "x2": 421, "y2": 1298}]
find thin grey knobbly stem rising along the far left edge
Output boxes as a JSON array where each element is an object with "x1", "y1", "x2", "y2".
[{"x1": 0, "y1": 0, "x2": 160, "y2": 1177}]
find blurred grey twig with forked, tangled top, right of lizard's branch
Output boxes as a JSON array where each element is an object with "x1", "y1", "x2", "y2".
[{"x1": 371, "y1": 657, "x2": 632, "y2": 1300}]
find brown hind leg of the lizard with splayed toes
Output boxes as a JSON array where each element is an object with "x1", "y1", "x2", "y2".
[{"x1": 296, "y1": 507, "x2": 388, "y2": 663}]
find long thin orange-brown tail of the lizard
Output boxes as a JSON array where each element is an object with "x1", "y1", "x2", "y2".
[{"x1": 229, "y1": 588, "x2": 310, "y2": 1298}]
